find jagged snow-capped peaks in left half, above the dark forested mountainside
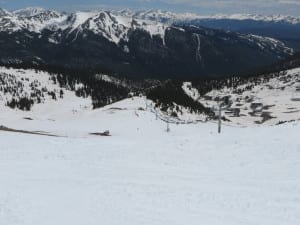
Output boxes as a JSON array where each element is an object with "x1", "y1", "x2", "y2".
[{"x1": 0, "y1": 7, "x2": 166, "y2": 43}]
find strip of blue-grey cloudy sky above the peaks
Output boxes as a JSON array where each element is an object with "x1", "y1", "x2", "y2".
[{"x1": 0, "y1": 0, "x2": 300, "y2": 16}]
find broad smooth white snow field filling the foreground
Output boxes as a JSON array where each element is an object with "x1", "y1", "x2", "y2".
[{"x1": 0, "y1": 94, "x2": 300, "y2": 225}]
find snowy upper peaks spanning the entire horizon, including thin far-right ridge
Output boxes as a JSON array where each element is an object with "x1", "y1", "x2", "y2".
[{"x1": 0, "y1": 7, "x2": 300, "y2": 44}]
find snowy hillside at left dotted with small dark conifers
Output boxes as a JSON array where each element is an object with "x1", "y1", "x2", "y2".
[{"x1": 0, "y1": 67, "x2": 92, "y2": 112}]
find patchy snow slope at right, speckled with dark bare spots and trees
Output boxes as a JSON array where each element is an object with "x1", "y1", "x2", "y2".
[{"x1": 183, "y1": 68, "x2": 300, "y2": 126}]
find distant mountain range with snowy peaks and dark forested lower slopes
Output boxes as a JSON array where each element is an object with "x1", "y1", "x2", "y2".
[{"x1": 0, "y1": 8, "x2": 300, "y2": 78}]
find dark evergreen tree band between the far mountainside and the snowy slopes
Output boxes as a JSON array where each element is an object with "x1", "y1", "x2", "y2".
[{"x1": 4, "y1": 53, "x2": 300, "y2": 111}]
